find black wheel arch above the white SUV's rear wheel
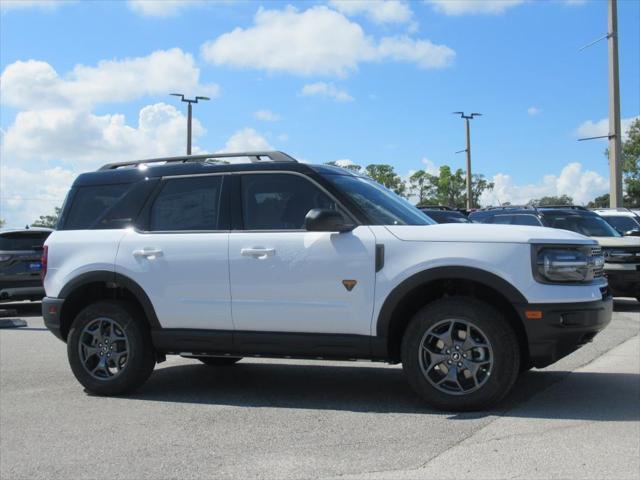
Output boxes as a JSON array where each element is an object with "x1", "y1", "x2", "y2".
[{"x1": 59, "y1": 270, "x2": 160, "y2": 339}]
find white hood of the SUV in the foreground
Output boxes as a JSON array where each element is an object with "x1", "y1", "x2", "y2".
[{"x1": 386, "y1": 223, "x2": 596, "y2": 244}]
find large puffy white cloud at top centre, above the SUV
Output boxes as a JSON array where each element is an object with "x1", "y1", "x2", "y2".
[{"x1": 202, "y1": 6, "x2": 455, "y2": 76}]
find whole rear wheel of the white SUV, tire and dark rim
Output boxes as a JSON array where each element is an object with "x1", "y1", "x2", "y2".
[{"x1": 67, "y1": 300, "x2": 156, "y2": 395}]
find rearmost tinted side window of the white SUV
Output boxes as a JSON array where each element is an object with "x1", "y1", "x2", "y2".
[{"x1": 64, "y1": 183, "x2": 130, "y2": 230}]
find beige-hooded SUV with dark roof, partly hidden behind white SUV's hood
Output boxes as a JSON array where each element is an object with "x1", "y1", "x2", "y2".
[{"x1": 469, "y1": 206, "x2": 640, "y2": 301}]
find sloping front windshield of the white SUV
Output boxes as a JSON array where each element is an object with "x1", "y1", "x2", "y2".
[{"x1": 324, "y1": 174, "x2": 435, "y2": 225}]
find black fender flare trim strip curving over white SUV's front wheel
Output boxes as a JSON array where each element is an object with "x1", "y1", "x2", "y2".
[{"x1": 376, "y1": 266, "x2": 527, "y2": 338}]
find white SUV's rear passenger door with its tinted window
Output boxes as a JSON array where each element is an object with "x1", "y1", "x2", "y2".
[{"x1": 116, "y1": 174, "x2": 233, "y2": 331}]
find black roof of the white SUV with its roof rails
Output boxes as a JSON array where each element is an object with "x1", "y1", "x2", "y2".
[{"x1": 74, "y1": 152, "x2": 357, "y2": 187}]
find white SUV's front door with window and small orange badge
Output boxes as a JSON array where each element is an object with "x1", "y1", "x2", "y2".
[{"x1": 229, "y1": 172, "x2": 375, "y2": 335}]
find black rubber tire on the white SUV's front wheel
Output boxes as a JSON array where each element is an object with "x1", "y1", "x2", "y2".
[{"x1": 402, "y1": 296, "x2": 520, "y2": 411}]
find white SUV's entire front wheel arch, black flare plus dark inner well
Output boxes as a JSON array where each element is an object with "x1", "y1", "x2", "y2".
[{"x1": 374, "y1": 266, "x2": 529, "y2": 362}]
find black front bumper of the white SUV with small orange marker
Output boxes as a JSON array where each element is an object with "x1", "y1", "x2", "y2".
[{"x1": 518, "y1": 295, "x2": 613, "y2": 368}]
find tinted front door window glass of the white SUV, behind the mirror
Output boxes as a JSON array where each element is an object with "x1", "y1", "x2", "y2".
[{"x1": 241, "y1": 173, "x2": 338, "y2": 230}]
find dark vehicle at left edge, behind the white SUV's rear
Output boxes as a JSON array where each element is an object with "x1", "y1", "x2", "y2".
[{"x1": 0, "y1": 227, "x2": 53, "y2": 301}]
